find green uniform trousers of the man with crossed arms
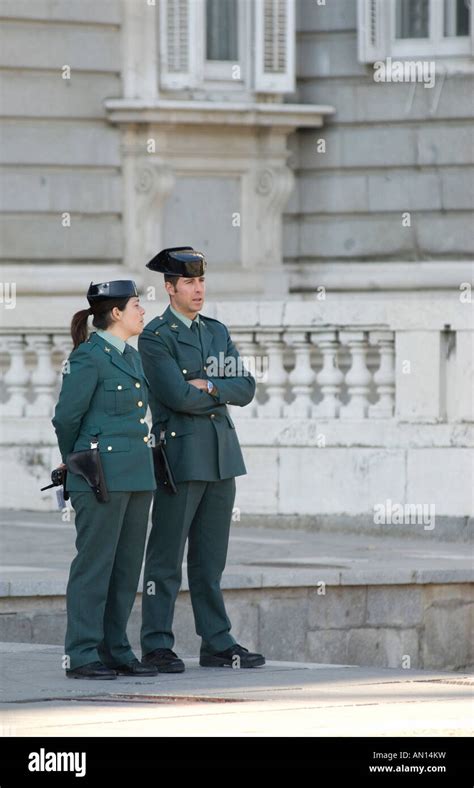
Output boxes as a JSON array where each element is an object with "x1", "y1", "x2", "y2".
[{"x1": 141, "y1": 477, "x2": 237, "y2": 655}]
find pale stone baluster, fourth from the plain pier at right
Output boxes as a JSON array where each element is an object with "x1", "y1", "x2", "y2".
[{"x1": 283, "y1": 331, "x2": 316, "y2": 419}]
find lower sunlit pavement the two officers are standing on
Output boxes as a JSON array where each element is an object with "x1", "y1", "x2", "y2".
[{"x1": 0, "y1": 643, "x2": 474, "y2": 737}]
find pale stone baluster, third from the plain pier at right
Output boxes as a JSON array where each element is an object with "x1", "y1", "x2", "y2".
[{"x1": 310, "y1": 330, "x2": 344, "y2": 419}]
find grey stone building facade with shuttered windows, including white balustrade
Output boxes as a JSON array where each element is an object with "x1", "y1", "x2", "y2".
[{"x1": 0, "y1": 0, "x2": 474, "y2": 522}]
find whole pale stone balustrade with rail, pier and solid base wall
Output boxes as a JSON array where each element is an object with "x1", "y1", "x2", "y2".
[{"x1": 0, "y1": 297, "x2": 474, "y2": 516}]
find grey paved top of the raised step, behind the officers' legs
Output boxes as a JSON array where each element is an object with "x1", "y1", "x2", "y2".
[{"x1": 0, "y1": 510, "x2": 473, "y2": 595}]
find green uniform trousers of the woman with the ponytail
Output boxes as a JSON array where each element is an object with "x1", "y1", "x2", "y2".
[{"x1": 65, "y1": 491, "x2": 152, "y2": 668}]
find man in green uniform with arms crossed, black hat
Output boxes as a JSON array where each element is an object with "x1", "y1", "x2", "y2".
[{"x1": 138, "y1": 247, "x2": 265, "y2": 673}]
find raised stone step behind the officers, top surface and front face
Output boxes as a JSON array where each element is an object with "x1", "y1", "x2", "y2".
[{"x1": 0, "y1": 512, "x2": 474, "y2": 671}]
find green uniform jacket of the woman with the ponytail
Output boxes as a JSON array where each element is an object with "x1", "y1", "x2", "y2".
[{"x1": 52, "y1": 333, "x2": 156, "y2": 492}]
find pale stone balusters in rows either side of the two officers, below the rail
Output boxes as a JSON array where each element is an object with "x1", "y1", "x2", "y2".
[{"x1": 0, "y1": 326, "x2": 395, "y2": 419}]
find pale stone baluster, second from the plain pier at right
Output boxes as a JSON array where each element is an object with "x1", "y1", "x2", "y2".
[{"x1": 339, "y1": 331, "x2": 372, "y2": 419}]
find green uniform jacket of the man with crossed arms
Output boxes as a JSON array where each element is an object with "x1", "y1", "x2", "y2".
[{"x1": 138, "y1": 307, "x2": 255, "y2": 482}]
